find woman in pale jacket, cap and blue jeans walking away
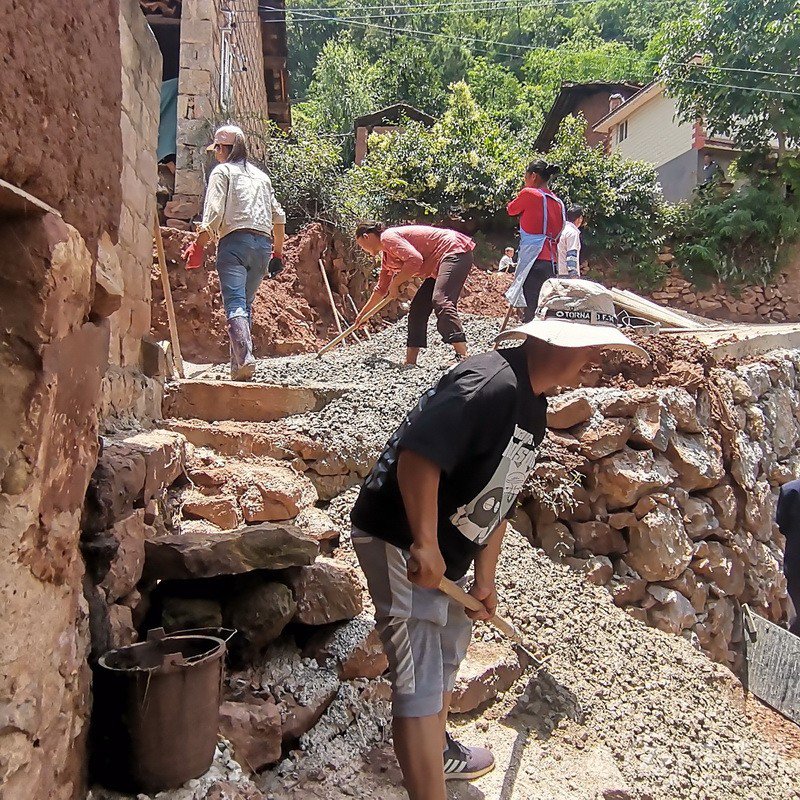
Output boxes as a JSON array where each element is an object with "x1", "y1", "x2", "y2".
[{"x1": 183, "y1": 125, "x2": 286, "y2": 381}]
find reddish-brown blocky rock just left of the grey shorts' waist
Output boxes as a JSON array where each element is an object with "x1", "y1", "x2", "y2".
[{"x1": 289, "y1": 558, "x2": 363, "y2": 625}]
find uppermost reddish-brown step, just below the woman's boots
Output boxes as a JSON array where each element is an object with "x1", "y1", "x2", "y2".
[{"x1": 163, "y1": 380, "x2": 346, "y2": 422}]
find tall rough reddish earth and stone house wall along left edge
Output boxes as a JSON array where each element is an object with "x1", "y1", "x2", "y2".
[{"x1": 0, "y1": 0, "x2": 160, "y2": 800}]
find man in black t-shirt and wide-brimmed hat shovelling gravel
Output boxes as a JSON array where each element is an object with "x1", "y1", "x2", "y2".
[{"x1": 351, "y1": 279, "x2": 644, "y2": 800}]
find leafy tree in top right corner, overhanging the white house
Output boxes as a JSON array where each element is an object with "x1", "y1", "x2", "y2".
[{"x1": 661, "y1": 0, "x2": 800, "y2": 155}]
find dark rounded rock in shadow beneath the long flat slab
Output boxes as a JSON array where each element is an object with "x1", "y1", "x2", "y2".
[{"x1": 223, "y1": 579, "x2": 297, "y2": 650}]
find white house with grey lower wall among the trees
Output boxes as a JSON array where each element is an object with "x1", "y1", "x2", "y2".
[{"x1": 594, "y1": 81, "x2": 738, "y2": 203}]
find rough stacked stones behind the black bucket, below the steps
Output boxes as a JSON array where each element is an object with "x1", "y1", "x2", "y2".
[{"x1": 81, "y1": 422, "x2": 388, "y2": 771}]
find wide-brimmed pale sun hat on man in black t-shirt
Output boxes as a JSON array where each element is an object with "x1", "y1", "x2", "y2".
[{"x1": 495, "y1": 278, "x2": 647, "y2": 357}]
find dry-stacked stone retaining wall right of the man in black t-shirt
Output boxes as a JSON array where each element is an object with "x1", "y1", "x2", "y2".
[{"x1": 525, "y1": 351, "x2": 800, "y2": 665}]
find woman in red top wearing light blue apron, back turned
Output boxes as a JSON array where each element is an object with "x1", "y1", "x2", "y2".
[{"x1": 506, "y1": 159, "x2": 566, "y2": 322}]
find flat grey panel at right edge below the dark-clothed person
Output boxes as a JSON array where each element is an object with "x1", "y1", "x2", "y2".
[{"x1": 742, "y1": 606, "x2": 800, "y2": 724}]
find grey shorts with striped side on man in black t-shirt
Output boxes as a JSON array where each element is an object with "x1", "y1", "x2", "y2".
[{"x1": 353, "y1": 528, "x2": 472, "y2": 717}]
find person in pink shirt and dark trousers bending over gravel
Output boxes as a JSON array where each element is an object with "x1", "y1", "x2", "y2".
[{"x1": 356, "y1": 222, "x2": 475, "y2": 365}]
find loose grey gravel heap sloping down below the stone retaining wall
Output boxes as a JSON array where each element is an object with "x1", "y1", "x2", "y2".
[{"x1": 498, "y1": 531, "x2": 800, "y2": 800}]
